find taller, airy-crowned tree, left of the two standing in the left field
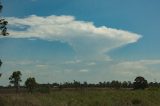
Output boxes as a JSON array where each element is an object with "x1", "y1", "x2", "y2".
[{"x1": 9, "y1": 71, "x2": 22, "y2": 92}]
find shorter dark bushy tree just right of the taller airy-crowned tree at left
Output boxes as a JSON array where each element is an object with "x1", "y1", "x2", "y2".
[{"x1": 25, "y1": 77, "x2": 37, "y2": 93}]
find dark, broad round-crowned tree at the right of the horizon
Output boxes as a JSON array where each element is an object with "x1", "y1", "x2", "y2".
[{"x1": 133, "y1": 76, "x2": 148, "y2": 89}]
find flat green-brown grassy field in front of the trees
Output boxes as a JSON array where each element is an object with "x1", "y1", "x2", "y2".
[{"x1": 0, "y1": 89, "x2": 160, "y2": 106}]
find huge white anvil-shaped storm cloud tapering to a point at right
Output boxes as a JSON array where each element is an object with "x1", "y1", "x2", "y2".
[{"x1": 6, "y1": 15, "x2": 141, "y2": 60}]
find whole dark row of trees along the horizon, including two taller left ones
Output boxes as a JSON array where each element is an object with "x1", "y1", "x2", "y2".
[{"x1": 0, "y1": 71, "x2": 160, "y2": 93}]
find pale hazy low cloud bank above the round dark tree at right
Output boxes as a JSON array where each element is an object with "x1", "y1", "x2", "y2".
[{"x1": 111, "y1": 60, "x2": 160, "y2": 80}]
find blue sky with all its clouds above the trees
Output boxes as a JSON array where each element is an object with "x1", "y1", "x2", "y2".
[{"x1": 0, "y1": 0, "x2": 160, "y2": 85}]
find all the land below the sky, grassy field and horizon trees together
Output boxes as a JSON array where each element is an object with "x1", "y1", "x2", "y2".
[{"x1": 0, "y1": 71, "x2": 160, "y2": 106}]
